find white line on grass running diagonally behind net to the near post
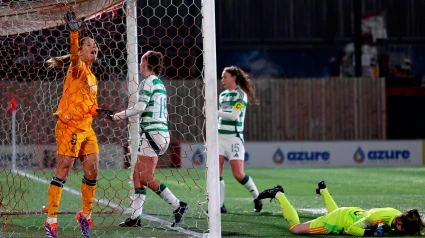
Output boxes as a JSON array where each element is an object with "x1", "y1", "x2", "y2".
[{"x1": 12, "y1": 170, "x2": 203, "y2": 238}]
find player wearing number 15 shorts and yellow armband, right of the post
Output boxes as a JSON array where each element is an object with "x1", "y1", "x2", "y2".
[{"x1": 218, "y1": 66, "x2": 263, "y2": 213}]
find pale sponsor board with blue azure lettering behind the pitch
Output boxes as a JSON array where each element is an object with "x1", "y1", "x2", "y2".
[{"x1": 182, "y1": 140, "x2": 423, "y2": 167}]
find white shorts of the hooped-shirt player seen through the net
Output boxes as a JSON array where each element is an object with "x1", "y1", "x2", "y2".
[{"x1": 137, "y1": 131, "x2": 170, "y2": 157}]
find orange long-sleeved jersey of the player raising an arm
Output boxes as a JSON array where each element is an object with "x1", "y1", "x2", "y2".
[{"x1": 55, "y1": 32, "x2": 98, "y2": 130}]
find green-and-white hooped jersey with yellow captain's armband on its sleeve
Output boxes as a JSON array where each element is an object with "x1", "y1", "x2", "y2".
[{"x1": 218, "y1": 87, "x2": 248, "y2": 138}]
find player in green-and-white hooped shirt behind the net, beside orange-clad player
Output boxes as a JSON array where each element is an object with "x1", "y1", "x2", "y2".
[{"x1": 113, "y1": 51, "x2": 188, "y2": 227}]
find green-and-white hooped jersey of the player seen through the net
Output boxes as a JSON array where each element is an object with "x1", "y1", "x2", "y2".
[{"x1": 139, "y1": 75, "x2": 168, "y2": 133}]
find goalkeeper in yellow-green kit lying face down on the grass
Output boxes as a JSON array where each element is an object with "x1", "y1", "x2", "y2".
[{"x1": 258, "y1": 181, "x2": 425, "y2": 236}]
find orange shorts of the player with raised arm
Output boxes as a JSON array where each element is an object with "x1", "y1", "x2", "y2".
[{"x1": 56, "y1": 120, "x2": 99, "y2": 157}]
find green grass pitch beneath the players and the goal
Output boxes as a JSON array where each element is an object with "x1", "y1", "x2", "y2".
[{"x1": 0, "y1": 166, "x2": 425, "y2": 237}]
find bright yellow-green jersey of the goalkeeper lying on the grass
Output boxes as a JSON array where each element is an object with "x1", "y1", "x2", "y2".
[{"x1": 310, "y1": 207, "x2": 401, "y2": 236}]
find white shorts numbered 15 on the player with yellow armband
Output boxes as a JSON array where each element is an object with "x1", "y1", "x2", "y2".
[{"x1": 218, "y1": 135, "x2": 245, "y2": 160}]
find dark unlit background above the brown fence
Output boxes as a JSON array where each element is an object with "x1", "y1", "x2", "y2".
[{"x1": 0, "y1": 0, "x2": 425, "y2": 139}]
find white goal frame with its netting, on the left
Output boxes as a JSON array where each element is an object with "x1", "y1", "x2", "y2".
[{"x1": 0, "y1": 0, "x2": 221, "y2": 238}]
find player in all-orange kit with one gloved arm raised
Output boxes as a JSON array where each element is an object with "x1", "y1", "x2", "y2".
[{"x1": 44, "y1": 12, "x2": 113, "y2": 237}]
